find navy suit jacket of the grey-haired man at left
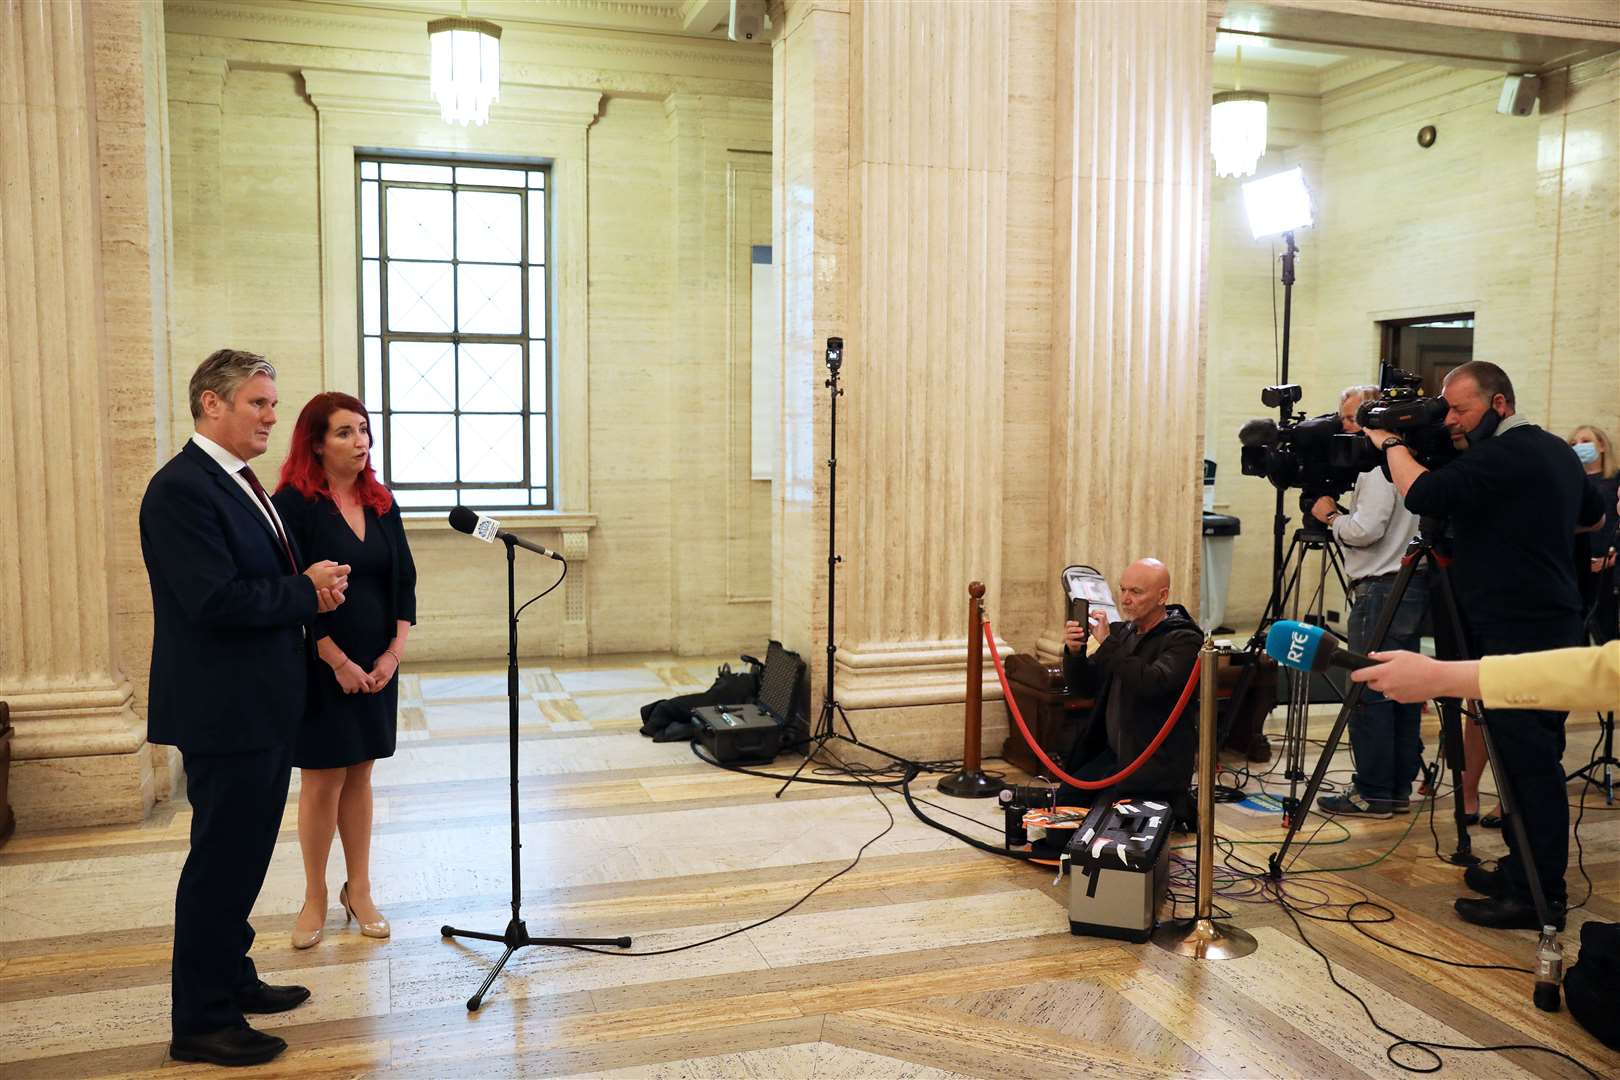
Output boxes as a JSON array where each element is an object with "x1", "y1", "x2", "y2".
[{"x1": 141, "y1": 442, "x2": 318, "y2": 755}]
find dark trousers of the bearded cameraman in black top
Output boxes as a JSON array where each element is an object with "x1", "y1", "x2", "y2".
[{"x1": 1469, "y1": 619, "x2": 1583, "y2": 904}]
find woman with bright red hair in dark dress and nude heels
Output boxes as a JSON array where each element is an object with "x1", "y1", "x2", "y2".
[{"x1": 274, "y1": 393, "x2": 416, "y2": 949}]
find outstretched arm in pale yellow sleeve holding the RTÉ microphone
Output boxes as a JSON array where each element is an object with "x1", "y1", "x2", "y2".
[{"x1": 1349, "y1": 641, "x2": 1620, "y2": 711}]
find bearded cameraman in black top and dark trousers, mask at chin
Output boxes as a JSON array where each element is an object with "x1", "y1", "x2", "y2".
[{"x1": 1366, "y1": 359, "x2": 1604, "y2": 929}]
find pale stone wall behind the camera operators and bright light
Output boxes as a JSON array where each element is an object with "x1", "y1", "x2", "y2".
[{"x1": 1209, "y1": 55, "x2": 1620, "y2": 627}]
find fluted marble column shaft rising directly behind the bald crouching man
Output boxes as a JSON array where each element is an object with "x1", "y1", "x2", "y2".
[{"x1": 1042, "y1": 0, "x2": 1213, "y2": 651}]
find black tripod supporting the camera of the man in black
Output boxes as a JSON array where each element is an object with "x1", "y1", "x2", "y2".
[{"x1": 1270, "y1": 518, "x2": 1557, "y2": 952}]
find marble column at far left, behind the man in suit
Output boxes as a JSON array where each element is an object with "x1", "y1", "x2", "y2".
[{"x1": 0, "y1": 0, "x2": 162, "y2": 829}]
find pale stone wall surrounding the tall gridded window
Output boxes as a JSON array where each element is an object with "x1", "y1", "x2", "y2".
[{"x1": 167, "y1": 3, "x2": 771, "y2": 662}]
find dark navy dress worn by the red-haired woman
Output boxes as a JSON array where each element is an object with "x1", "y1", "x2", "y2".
[{"x1": 275, "y1": 487, "x2": 416, "y2": 769}]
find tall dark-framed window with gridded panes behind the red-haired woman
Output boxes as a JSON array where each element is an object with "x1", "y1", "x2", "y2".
[{"x1": 356, "y1": 155, "x2": 556, "y2": 510}]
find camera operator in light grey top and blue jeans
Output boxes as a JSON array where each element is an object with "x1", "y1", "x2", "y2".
[{"x1": 1311, "y1": 385, "x2": 1429, "y2": 818}]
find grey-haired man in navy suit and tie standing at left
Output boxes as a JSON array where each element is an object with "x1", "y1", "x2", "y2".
[{"x1": 141, "y1": 350, "x2": 348, "y2": 1065}]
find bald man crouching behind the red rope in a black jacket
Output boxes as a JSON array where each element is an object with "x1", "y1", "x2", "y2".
[{"x1": 1058, "y1": 559, "x2": 1204, "y2": 821}]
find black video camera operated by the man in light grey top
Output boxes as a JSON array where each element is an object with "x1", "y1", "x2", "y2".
[{"x1": 1238, "y1": 384, "x2": 1382, "y2": 513}]
